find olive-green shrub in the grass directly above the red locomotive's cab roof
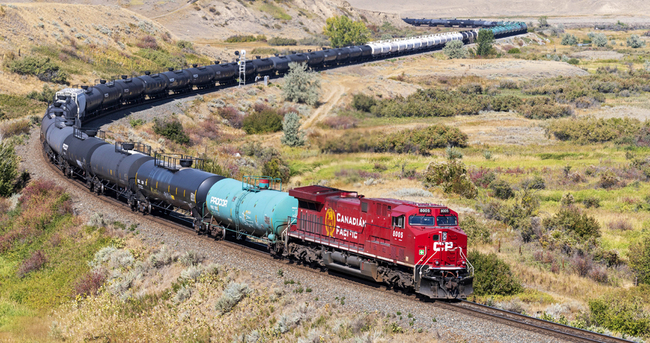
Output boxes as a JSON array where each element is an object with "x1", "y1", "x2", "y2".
[{"x1": 424, "y1": 160, "x2": 478, "y2": 199}]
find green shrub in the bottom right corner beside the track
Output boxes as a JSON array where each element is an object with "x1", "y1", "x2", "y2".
[{"x1": 589, "y1": 285, "x2": 650, "y2": 337}]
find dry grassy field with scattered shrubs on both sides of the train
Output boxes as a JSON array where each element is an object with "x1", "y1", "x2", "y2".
[{"x1": 0, "y1": 1, "x2": 650, "y2": 340}]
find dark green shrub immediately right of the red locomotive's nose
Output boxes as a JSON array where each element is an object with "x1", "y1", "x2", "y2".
[{"x1": 467, "y1": 251, "x2": 524, "y2": 295}]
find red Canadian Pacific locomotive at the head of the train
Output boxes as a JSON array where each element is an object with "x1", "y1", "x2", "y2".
[{"x1": 285, "y1": 186, "x2": 473, "y2": 299}]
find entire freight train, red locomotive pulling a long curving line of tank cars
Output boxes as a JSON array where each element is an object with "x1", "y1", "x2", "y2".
[{"x1": 35, "y1": 23, "x2": 526, "y2": 299}]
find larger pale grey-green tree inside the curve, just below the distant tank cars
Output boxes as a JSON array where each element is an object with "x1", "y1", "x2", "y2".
[{"x1": 282, "y1": 62, "x2": 320, "y2": 106}]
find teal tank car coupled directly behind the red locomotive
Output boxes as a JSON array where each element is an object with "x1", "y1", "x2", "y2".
[{"x1": 206, "y1": 177, "x2": 298, "y2": 241}]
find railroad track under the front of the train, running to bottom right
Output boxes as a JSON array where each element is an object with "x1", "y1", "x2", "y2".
[{"x1": 39, "y1": 142, "x2": 632, "y2": 343}]
